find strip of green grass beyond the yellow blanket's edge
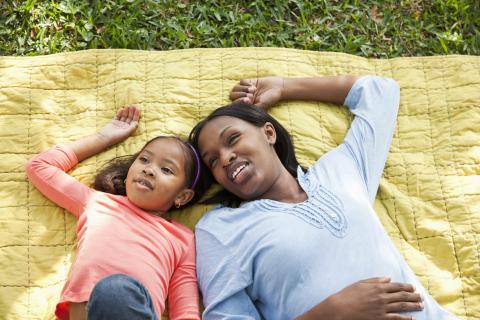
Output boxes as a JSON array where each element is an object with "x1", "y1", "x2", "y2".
[{"x1": 0, "y1": 0, "x2": 480, "y2": 58}]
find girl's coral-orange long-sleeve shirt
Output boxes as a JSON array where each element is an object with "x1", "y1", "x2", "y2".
[{"x1": 26, "y1": 146, "x2": 200, "y2": 319}]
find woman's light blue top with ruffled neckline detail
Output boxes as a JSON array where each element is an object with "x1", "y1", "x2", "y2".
[{"x1": 195, "y1": 76, "x2": 457, "y2": 320}]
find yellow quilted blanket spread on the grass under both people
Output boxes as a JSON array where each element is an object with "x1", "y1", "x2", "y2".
[{"x1": 0, "y1": 48, "x2": 480, "y2": 320}]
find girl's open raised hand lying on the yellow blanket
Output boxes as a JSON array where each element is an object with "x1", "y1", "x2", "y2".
[{"x1": 98, "y1": 106, "x2": 140, "y2": 144}]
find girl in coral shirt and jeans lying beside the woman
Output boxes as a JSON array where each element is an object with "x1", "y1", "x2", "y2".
[{"x1": 26, "y1": 106, "x2": 203, "y2": 320}]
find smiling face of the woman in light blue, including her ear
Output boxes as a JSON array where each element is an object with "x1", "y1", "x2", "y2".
[{"x1": 198, "y1": 116, "x2": 281, "y2": 200}]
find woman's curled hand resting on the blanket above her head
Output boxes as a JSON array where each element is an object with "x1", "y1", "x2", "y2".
[{"x1": 230, "y1": 77, "x2": 284, "y2": 110}]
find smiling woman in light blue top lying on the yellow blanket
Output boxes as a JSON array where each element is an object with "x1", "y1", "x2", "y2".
[{"x1": 190, "y1": 76, "x2": 462, "y2": 320}]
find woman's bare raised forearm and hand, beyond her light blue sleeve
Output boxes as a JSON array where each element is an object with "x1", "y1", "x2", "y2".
[{"x1": 230, "y1": 75, "x2": 358, "y2": 109}]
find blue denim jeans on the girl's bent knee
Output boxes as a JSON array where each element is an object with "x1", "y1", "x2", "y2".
[{"x1": 87, "y1": 274, "x2": 157, "y2": 320}]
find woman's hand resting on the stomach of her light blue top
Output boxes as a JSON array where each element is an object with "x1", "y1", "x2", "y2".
[{"x1": 297, "y1": 278, "x2": 423, "y2": 320}]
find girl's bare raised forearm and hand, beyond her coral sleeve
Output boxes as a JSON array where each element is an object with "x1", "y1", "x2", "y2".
[{"x1": 67, "y1": 106, "x2": 140, "y2": 162}]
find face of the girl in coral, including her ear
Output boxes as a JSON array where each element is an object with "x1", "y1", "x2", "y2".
[{"x1": 125, "y1": 138, "x2": 193, "y2": 212}]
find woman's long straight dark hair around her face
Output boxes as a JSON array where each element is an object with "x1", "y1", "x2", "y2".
[{"x1": 188, "y1": 102, "x2": 305, "y2": 207}]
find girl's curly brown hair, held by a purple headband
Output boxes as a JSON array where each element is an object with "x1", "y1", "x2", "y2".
[{"x1": 93, "y1": 136, "x2": 212, "y2": 208}]
